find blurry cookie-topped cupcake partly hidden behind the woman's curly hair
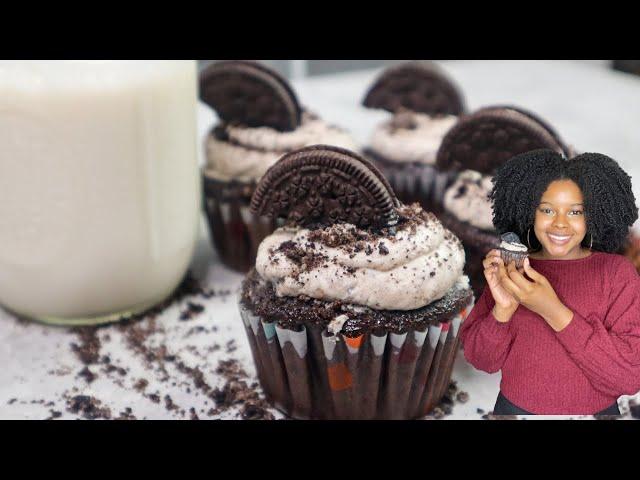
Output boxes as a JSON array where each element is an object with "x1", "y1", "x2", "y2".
[{"x1": 436, "y1": 106, "x2": 572, "y2": 296}]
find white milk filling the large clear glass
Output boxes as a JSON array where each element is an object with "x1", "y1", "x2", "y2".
[{"x1": 0, "y1": 61, "x2": 200, "y2": 323}]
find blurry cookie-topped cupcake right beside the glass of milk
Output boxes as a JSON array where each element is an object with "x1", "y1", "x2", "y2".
[{"x1": 200, "y1": 61, "x2": 357, "y2": 272}]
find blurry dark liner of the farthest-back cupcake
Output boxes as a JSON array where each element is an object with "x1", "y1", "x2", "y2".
[{"x1": 366, "y1": 150, "x2": 455, "y2": 214}]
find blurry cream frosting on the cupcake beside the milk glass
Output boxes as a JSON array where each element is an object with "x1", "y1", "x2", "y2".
[{"x1": 205, "y1": 112, "x2": 358, "y2": 181}]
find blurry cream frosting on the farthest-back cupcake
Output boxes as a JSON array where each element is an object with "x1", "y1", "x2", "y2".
[{"x1": 371, "y1": 111, "x2": 458, "y2": 165}]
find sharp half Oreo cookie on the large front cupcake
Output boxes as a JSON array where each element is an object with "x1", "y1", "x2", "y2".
[{"x1": 251, "y1": 145, "x2": 400, "y2": 230}]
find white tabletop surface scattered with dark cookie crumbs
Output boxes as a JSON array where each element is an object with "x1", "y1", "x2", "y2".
[{"x1": 0, "y1": 61, "x2": 640, "y2": 419}]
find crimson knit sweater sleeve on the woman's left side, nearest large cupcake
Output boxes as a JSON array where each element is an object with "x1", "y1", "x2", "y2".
[{"x1": 460, "y1": 287, "x2": 513, "y2": 373}]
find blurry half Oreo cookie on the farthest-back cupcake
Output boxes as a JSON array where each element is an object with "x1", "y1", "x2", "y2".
[{"x1": 362, "y1": 61, "x2": 465, "y2": 116}]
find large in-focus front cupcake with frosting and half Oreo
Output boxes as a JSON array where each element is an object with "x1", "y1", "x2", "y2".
[{"x1": 240, "y1": 146, "x2": 473, "y2": 419}]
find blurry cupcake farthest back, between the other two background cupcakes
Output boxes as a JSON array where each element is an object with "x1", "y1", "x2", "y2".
[{"x1": 363, "y1": 62, "x2": 465, "y2": 213}]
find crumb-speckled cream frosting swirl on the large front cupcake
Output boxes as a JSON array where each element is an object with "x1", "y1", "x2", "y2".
[{"x1": 256, "y1": 210, "x2": 465, "y2": 310}]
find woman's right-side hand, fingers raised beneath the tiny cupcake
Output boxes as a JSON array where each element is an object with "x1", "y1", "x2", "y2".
[{"x1": 498, "y1": 258, "x2": 573, "y2": 332}]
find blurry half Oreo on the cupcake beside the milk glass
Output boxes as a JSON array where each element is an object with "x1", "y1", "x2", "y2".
[{"x1": 200, "y1": 60, "x2": 302, "y2": 132}]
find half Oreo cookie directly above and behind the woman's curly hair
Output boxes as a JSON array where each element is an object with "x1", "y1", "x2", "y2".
[{"x1": 436, "y1": 107, "x2": 568, "y2": 175}]
